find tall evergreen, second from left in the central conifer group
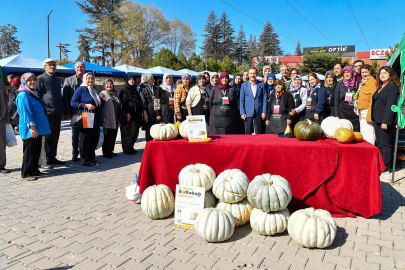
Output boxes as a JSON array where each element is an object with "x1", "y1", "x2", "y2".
[{"x1": 216, "y1": 12, "x2": 235, "y2": 61}]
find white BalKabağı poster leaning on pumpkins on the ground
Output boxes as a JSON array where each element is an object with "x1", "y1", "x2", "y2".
[{"x1": 174, "y1": 185, "x2": 205, "y2": 231}]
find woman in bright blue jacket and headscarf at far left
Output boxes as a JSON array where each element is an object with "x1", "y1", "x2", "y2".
[{"x1": 15, "y1": 73, "x2": 51, "y2": 181}]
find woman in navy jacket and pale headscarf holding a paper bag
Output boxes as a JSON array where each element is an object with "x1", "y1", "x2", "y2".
[{"x1": 70, "y1": 73, "x2": 103, "y2": 166}]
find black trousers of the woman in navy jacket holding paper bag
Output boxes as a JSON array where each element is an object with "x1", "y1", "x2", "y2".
[{"x1": 79, "y1": 127, "x2": 100, "y2": 162}]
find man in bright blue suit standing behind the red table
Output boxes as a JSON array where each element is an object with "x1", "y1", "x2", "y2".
[{"x1": 240, "y1": 67, "x2": 267, "y2": 134}]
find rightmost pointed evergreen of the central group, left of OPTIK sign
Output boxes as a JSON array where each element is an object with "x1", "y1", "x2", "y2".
[{"x1": 258, "y1": 21, "x2": 283, "y2": 56}]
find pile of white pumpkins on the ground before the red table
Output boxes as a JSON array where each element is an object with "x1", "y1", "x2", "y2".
[{"x1": 142, "y1": 164, "x2": 337, "y2": 248}]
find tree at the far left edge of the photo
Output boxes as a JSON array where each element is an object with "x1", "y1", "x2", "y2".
[{"x1": 0, "y1": 24, "x2": 22, "y2": 59}]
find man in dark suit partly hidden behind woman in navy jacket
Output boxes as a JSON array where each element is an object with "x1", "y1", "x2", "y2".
[{"x1": 62, "y1": 62, "x2": 86, "y2": 161}]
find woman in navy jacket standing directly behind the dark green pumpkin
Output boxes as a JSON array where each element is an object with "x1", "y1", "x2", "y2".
[{"x1": 305, "y1": 73, "x2": 328, "y2": 124}]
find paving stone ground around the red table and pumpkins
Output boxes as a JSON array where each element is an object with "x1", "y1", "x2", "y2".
[{"x1": 0, "y1": 121, "x2": 405, "y2": 270}]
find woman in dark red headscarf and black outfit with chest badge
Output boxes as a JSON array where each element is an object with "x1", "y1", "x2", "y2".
[{"x1": 210, "y1": 72, "x2": 238, "y2": 134}]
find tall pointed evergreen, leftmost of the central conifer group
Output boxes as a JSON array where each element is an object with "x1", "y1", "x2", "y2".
[{"x1": 200, "y1": 10, "x2": 220, "y2": 61}]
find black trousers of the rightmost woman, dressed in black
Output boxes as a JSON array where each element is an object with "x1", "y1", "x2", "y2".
[{"x1": 374, "y1": 122, "x2": 395, "y2": 169}]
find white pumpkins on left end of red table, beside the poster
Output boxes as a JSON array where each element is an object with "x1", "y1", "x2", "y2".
[{"x1": 150, "y1": 121, "x2": 212, "y2": 142}]
